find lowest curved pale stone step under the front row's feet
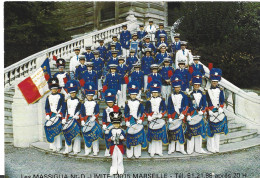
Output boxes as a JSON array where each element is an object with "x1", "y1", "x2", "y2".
[{"x1": 31, "y1": 135, "x2": 260, "y2": 162}]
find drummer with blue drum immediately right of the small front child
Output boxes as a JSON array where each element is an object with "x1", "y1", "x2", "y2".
[{"x1": 124, "y1": 81, "x2": 147, "y2": 158}]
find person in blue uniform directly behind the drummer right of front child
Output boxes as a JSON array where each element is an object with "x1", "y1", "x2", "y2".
[{"x1": 131, "y1": 63, "x2": 144, "y2": 100}]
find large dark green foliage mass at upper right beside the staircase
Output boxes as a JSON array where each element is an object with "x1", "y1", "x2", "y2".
[{"x1": 178, "y1": 2, "x2": 260, "y2": 87}]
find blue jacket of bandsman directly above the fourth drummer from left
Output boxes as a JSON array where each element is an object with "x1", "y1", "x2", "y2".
[{"x1": 104, "y1": 73, "x2": 122, "y2": 92}]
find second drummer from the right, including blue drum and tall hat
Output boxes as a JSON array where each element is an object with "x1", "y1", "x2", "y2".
[{"x1": 187, "y1": 71, "x2": 206, "y2": 154}]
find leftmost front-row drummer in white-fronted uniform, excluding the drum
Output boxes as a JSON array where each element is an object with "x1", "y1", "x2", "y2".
[{"x1": 45, "y1": 77, "x2": 64, "y2": 152}]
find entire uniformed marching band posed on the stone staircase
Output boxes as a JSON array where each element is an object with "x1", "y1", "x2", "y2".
[{"x1": 45, "y1": 20, "x2": 228, "y2": 174}]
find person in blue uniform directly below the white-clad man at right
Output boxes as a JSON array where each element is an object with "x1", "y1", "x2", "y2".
[{"x1": 175, "y1": 56, "x2": 191, "y2": 93}]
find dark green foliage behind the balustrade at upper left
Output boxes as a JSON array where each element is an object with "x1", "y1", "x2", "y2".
[{"x1": 4, "y1": 2, "x2": 70, "y2": 67}]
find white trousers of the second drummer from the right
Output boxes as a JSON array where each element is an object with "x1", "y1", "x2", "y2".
[{"x1": 187, "y1": 135, "x2": 204, "y2": 154}]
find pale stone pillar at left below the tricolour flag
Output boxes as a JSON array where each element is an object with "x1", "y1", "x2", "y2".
[{"x1": 12, "y1": 78, "x2": 39, "y2": 147}]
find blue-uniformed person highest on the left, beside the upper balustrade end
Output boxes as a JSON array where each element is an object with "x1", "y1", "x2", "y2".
[{"x1": 120, "y1": 24, "x2": 132, "y2": 57}]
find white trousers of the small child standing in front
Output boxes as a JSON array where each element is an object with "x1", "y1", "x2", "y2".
[{"x1": 110, "y1": 145, "x2": 124, "y2": 175}]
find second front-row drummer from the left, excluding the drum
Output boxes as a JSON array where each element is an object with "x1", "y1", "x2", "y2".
[{"x1": 62, "y1": 80, "x2": 81, "y2": 155}]
